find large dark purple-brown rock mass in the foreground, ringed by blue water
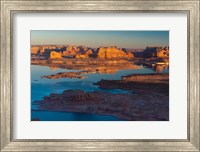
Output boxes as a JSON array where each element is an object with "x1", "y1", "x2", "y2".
[{"x1": 34, "y1": 90, "x2": 169, "y2": 121}]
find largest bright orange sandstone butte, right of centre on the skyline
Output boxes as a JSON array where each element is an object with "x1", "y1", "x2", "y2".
[{"x1": 97, "y1": 46, "x2": 134, "y2": 59}]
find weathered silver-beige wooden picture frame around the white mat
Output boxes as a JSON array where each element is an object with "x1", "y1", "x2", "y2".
[{"x1": 0, "y1": 0, "x2": 200, "y2": 152}]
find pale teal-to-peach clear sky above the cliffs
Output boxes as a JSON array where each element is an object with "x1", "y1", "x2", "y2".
[{"x1": 31, "y1": 30, "x2": 169, "y2": 48}]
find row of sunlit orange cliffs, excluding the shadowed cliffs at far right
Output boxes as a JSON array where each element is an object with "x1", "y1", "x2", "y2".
[{"x1": 31, "y1": 45, "x2": 134, "y2": 60}]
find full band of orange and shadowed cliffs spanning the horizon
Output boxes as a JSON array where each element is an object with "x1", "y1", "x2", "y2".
[{"x1": 31, "y1": 45, "x2": 169, "y2": 60}]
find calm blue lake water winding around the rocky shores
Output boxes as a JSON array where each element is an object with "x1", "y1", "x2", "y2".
[{"x1": 31, "y1": 65, "x2": 169, "y2": 121}]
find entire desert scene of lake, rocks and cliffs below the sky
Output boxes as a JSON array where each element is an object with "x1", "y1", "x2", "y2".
[{"x1": 31, "y1": 30, "x2": 169, "y2": 121}]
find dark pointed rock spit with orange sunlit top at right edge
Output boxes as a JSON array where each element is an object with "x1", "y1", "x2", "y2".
[{"x1": 94, "y1": 74, "x2": 169, "y2": 96}]
